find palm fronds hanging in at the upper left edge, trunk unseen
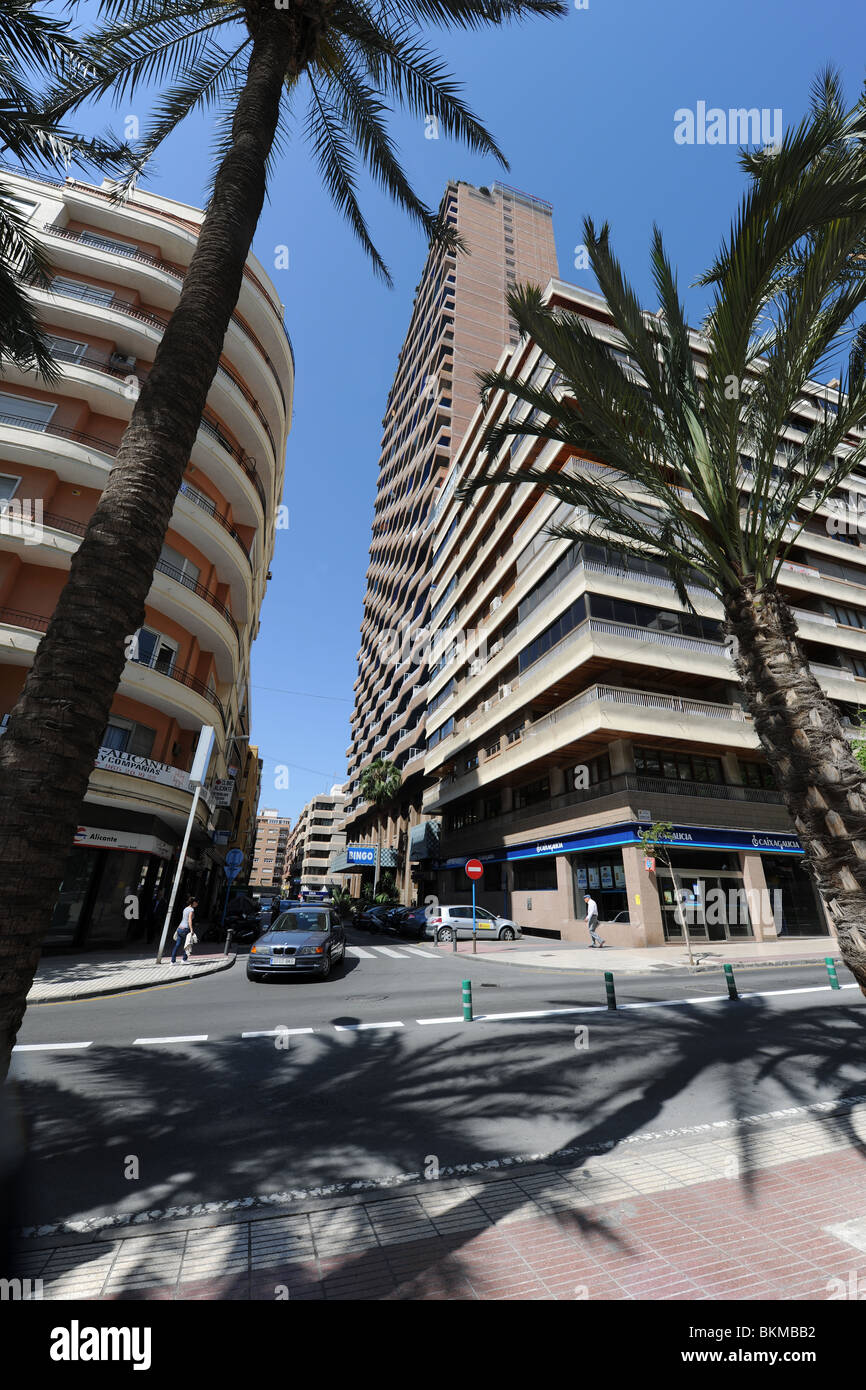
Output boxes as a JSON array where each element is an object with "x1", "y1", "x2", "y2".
[{"x1": 0, "y1": 0, "x2": 128, "y2": 381}]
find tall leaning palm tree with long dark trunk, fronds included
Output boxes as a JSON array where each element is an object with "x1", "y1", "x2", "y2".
[{"x1": 0, "y1": 0, "x2": 567, "y2": 1074}]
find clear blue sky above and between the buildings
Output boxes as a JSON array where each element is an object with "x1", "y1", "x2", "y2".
[{"x1": 69, "y1": 0, "x2": 866, "y2": 816}]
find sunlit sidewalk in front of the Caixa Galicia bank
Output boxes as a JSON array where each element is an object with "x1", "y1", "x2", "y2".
[{"x1": 480, "y1": 937, "x2": 841, "y2": 974}]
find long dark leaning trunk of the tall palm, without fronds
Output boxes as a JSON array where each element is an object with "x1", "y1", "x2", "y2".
[{"x1": 0, "y1": 7, "x2": 299, "y2": 1077}]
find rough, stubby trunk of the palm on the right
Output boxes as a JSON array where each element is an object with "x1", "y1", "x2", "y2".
[{"x1": 724, "y1": 585, "x2": 866, "y2": 994}]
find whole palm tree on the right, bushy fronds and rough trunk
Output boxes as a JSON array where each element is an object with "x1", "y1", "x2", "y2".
[{"x1": 463, "y1": 81, "x2": 866, "y2": 992}]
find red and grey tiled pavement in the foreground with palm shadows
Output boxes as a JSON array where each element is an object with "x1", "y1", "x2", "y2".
[{"x1": 21, "y1": 1105, "x2": 866, "y2": 1300}]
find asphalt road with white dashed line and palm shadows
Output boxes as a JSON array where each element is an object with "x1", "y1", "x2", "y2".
[{"x1": 13, "y1": 933, "x2": 866, "y2": 1225}]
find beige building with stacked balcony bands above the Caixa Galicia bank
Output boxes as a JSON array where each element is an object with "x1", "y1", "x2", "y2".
[{"x1": 423, "y1": 279, "x2": 866, "y2": 945}]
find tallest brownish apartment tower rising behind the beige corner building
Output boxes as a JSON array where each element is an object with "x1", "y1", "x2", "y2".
[{"x1": 346, "y1": 182, "x2": 557, "y2": 898}]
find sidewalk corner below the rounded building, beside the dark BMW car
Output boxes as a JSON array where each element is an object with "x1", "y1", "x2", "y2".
[{"x1": 26, "y1": 942, "x2": 235, "y2": 1005}]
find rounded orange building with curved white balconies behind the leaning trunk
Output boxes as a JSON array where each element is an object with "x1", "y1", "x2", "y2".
[{"x1": 0, "y1": 162, "x2": 293, "y2": 945}]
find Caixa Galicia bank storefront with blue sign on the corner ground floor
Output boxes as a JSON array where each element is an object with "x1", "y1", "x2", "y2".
[{"x1": 439, "y1": 821, "x2": 827, "y2": 945}]
